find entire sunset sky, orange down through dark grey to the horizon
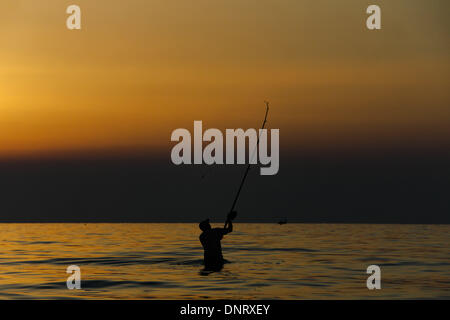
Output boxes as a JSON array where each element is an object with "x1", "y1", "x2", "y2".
[{"x1": 0, "y1": 0, "x2": 450, "y2": 223}]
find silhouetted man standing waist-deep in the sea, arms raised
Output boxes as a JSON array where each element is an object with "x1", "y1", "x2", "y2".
[{"x1": 199, "y1": 212, "x2": 236, "y2": 271}]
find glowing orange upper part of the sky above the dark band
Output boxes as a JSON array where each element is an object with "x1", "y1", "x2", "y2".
[{"x1": 0, "y1": 0, "x2": 450, "y2": 156}]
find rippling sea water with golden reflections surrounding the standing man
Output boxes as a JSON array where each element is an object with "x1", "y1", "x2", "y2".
[{"x1": 0, "y1": 223, "x2": 450, "y2": 299}]
